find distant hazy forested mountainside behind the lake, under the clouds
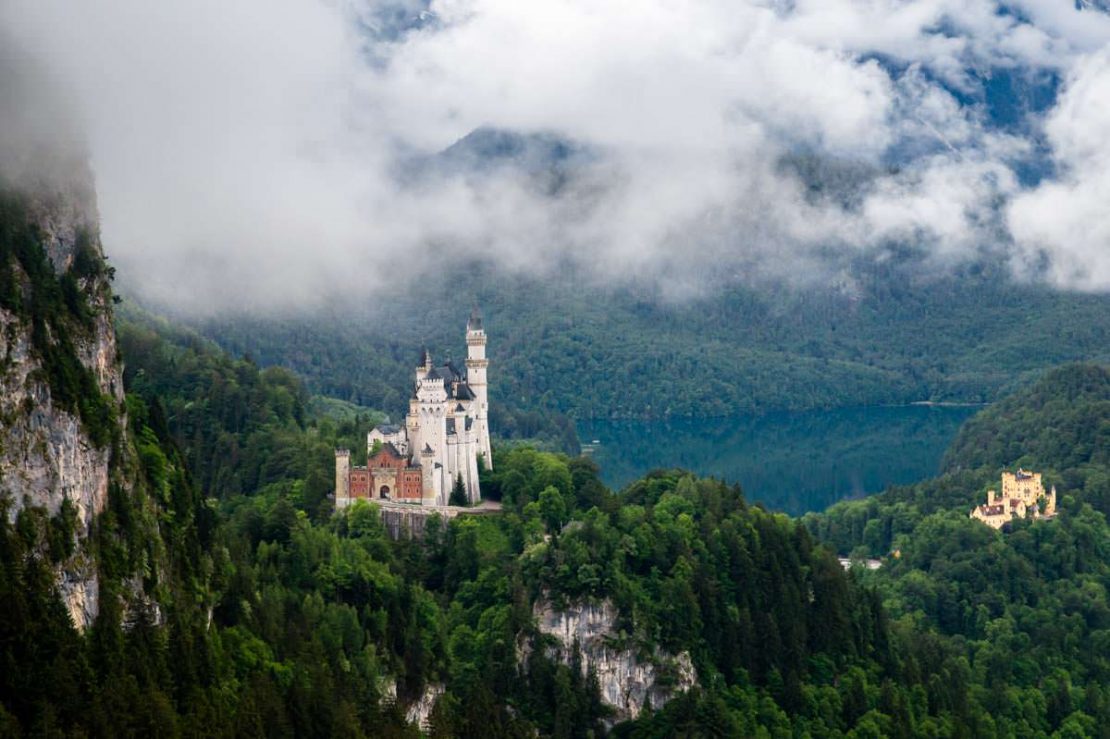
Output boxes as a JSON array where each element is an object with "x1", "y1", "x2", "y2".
[{"x1": 179, "y1": 255, "x2": 1110, "y2": 419}]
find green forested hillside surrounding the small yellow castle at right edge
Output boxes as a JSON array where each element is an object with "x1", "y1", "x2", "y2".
[{"x1": 805, "y1": 365, "x2": 1110, "y2": 737}]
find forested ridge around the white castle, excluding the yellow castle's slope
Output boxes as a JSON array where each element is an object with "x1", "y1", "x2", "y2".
[{"x1": 0, "y1": 297, "x2": 901, "y2": 736}]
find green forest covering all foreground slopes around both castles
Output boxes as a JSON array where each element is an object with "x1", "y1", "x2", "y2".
[{"x1": 0, "y1": 187, "x2": 1110, "y2": 738}]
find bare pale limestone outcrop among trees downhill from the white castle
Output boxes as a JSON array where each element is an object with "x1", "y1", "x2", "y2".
[{"x1": 533, "y1": 600, "x2": 696, "y2": 722}]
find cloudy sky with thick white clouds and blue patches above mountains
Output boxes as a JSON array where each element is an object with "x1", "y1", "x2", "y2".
[{"x1": 0, "y1": 0, "x2": 1110, "y2": 311}]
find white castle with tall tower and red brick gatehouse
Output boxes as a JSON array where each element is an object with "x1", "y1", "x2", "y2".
[{"x1": 335, "y1": 308, "x2": 493, "y2": 508}]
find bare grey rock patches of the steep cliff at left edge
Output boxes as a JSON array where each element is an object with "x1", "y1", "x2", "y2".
[{"x1": 0, "y1": 184, "x2": 125, "y2": 628}]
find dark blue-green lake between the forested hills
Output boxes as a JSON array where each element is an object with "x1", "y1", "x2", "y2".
[{"x1": 578, "y1": 406, "x2": 977, "y2": 514}]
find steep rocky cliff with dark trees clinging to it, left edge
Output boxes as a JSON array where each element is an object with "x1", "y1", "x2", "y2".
[{"x1": 0, "y1": 175, "x2": 125, "y2": 628}]
